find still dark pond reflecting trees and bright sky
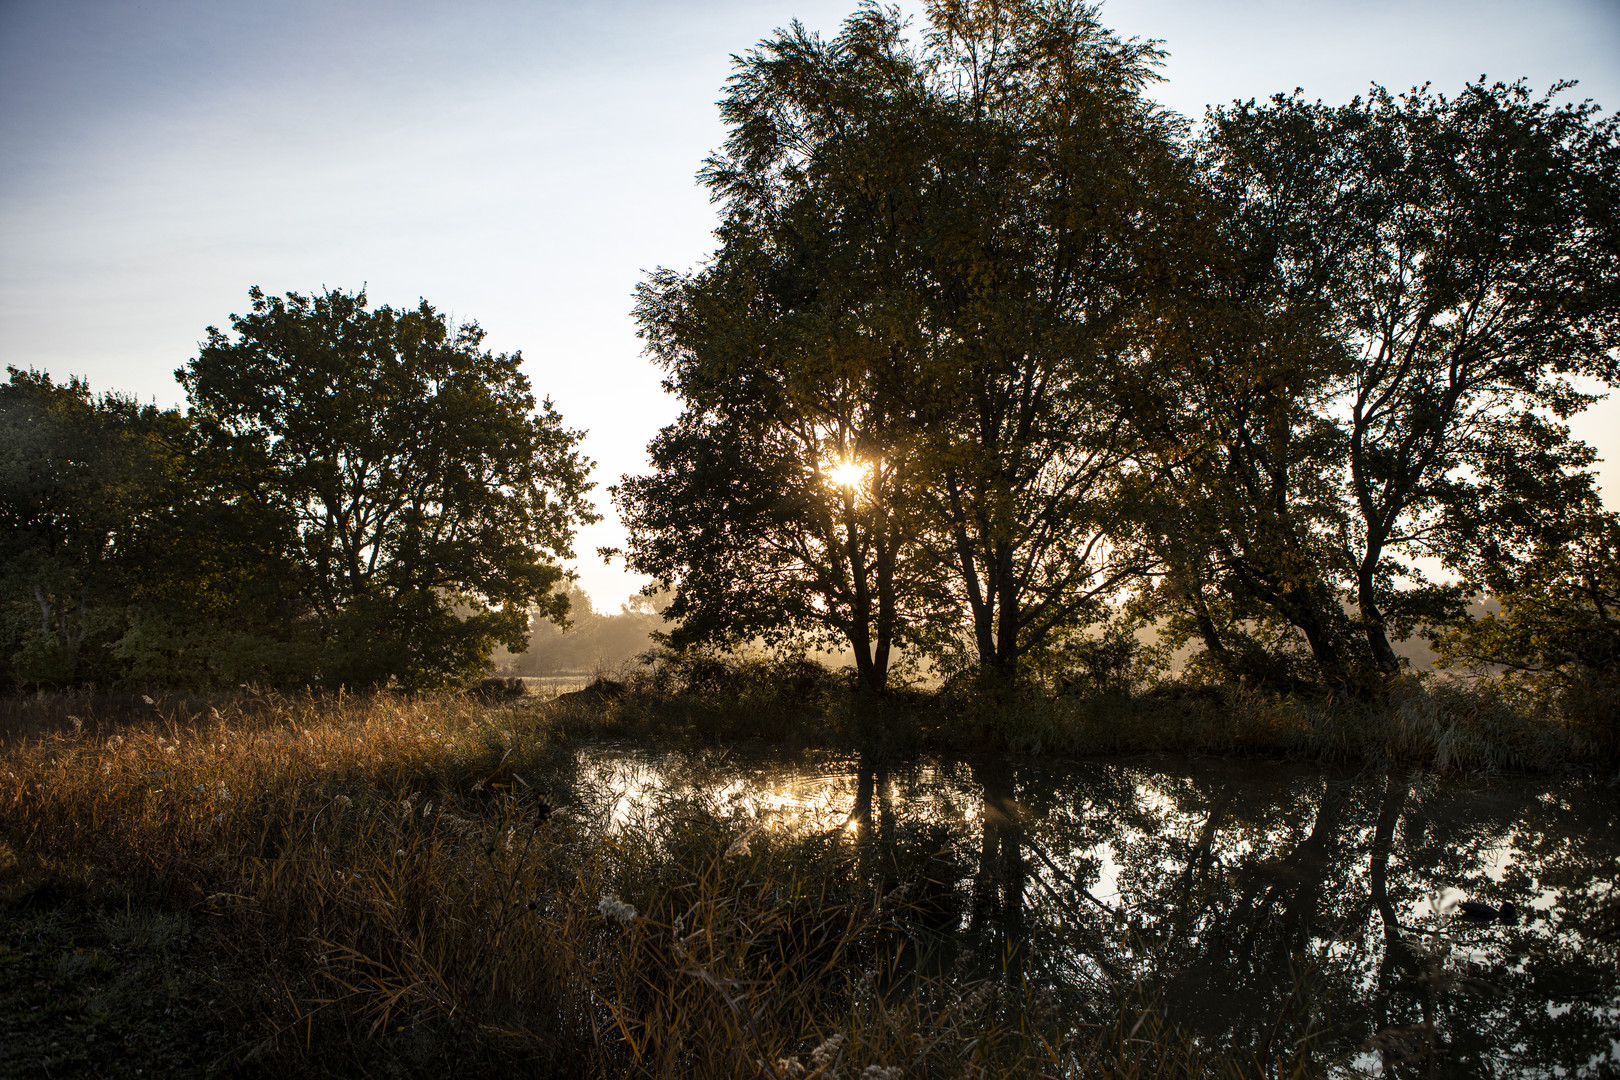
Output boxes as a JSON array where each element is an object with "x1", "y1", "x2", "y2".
[{"x1": 559, "y1": 746, "x2": 1620, "y2": 1077}]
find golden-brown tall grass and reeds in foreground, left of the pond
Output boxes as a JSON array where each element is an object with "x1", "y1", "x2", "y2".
[{"x1": 0, "y1": 691, "x2": 1312, "y2": 1080}]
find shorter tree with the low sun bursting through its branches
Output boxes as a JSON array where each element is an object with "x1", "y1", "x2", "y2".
[{"x1": 614, "y1": 239, "x2": 933, "y2": 693}]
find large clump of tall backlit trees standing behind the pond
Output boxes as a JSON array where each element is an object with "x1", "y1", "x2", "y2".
[{"x1": 617, "y1": 0, "x2": 1620, "y2": 693}]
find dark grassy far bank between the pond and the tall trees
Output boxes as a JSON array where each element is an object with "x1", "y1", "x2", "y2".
[{"x1": 548, "y1": 654, "x2": 1620, "y2": 771}]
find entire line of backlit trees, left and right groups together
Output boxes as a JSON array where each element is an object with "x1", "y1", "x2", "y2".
[{"x1": 0, "y1": 0, "x2": 1620, "y2": 711}]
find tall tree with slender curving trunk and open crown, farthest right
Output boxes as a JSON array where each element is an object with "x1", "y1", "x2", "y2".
[{"x1": 1142, "y1": 81, "x2": 1620, "y2": 690}]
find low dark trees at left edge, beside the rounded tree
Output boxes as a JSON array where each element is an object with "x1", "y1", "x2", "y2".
[{"x1": 0, "y1": 369, "x2": 319, "y2": 687}]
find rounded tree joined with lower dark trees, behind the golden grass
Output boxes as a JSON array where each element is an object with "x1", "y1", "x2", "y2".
[{"x1": 0, "y1": 290, "x2": 595, "y2": 688}]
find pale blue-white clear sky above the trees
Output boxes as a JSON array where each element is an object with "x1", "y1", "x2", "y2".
[{"x1": 0, "y1": 0, "x2": 1620, "y2": 612}]
